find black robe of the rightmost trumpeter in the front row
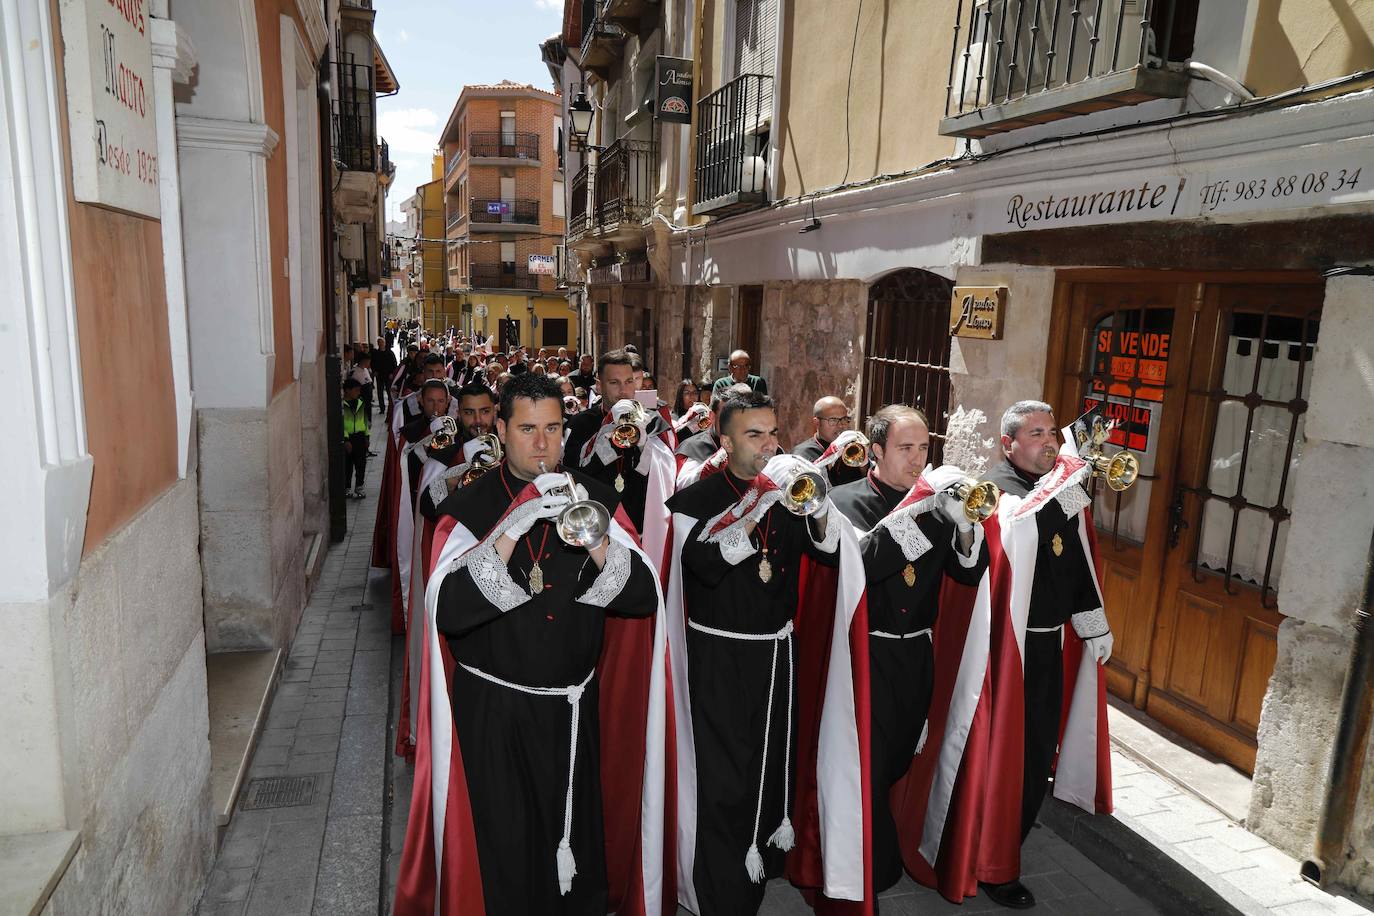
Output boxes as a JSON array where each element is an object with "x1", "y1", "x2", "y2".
[{"x1": 988, "y1": 461, "x2": 1102, "y2": 839}]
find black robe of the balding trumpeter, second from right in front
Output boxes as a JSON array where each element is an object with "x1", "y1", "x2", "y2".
[{"x1": 830, "y1": 474, "x2": 988, "y2": 891}]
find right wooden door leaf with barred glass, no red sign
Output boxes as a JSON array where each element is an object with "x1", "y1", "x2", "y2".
[{"x1": 1146, "y1": 283, "x2": 1322, "y2": 773}]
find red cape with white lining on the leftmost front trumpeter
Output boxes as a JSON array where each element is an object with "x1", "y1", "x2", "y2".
[{"x1": 393, "y1": 486, "x2": 676, "y2": 916}]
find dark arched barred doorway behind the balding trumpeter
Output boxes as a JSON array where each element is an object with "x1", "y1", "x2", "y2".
[{"x1": 863, "y1": 268, "x2": 954, "y2": 464}]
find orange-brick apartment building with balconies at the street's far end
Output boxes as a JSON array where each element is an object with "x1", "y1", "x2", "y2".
[{"x1": 440, "y1": 81, "x2": 578, "y2": 349}]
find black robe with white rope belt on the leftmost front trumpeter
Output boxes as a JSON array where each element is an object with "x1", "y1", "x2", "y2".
[{"x1": 436, "y1": 464, "x2": 658, "y2": 916}]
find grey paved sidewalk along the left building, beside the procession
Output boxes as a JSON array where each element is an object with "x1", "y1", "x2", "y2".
[{"x1": 198, "y1": 419, "x2": 392, "y2": 916}]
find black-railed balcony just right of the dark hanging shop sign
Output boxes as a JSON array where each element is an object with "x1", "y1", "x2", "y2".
[{"x1": 692, "y1": 73, "x2": 772, "y2": 217}]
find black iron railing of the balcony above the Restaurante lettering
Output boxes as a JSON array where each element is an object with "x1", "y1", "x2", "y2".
[{"x1": 954, "y1": 0, "x2": 1160, "y2": 111}]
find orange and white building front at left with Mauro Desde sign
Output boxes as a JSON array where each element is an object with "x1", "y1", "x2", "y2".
[{"x1": 0, "y1": 0, "x2": 398, "y2": 913}]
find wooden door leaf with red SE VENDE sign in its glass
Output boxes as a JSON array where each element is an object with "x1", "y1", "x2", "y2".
[{"x1": 1047, "y1": 280, "x2": 1193, "y2": 706}]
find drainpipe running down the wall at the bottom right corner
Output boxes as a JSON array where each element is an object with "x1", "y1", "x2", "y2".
[{"x1": 1300, "y1": 521, "x2": 1374, "y2": 887}]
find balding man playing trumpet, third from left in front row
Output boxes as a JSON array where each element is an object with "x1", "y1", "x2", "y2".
[{"x1": 831, "y1": 404, "x2": 988, "y2": 893}]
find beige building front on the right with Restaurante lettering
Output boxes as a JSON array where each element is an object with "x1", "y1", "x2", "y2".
[{"x1": 565, "y1": 0, "x2": 1374, "y2": 893}]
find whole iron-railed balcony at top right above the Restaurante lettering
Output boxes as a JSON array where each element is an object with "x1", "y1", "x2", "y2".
[{"x1": 940, "y1": 0, "x2": 1197, "y2": 137}]
